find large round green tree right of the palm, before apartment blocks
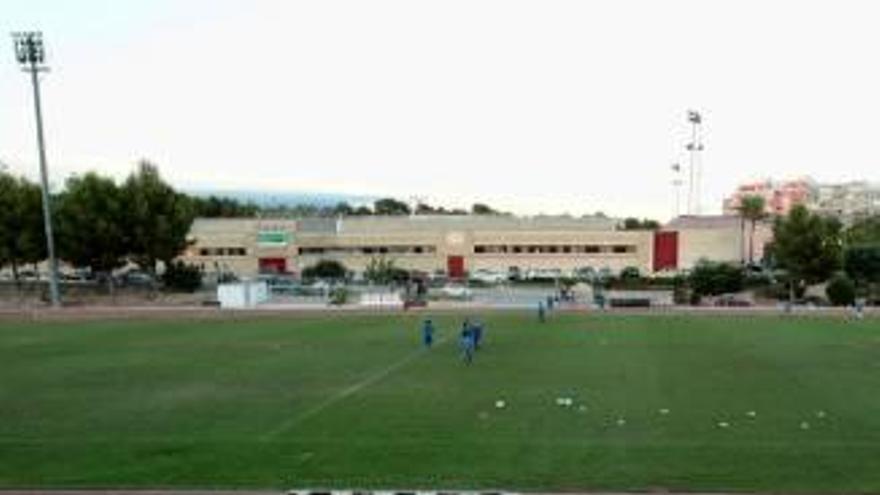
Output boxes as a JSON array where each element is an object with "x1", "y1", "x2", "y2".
[{"x1": 772, "y1": 205, "x2": 843, "y2": 298}]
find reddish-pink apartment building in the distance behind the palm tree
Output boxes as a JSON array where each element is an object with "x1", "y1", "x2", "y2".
[{"x1": 722, "y1": 177, "x2": 819, "y2": 215}]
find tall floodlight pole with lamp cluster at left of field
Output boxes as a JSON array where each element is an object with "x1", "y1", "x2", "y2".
[{"x1": 12, "y1": 31, "x2": 61, "y2": 308}]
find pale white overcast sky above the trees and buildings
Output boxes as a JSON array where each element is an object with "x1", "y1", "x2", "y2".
[{"x1": 0, "y1": 0, "x2": 880, "y2": 219}]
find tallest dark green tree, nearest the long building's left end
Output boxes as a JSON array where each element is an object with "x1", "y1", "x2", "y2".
[{"x1": 121, "y1": 161, "x2": 195, "y2": 274}]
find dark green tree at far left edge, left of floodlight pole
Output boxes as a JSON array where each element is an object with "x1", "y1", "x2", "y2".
[{"x1": 0, "y1": 172, "x2": 47, "y2": 282}]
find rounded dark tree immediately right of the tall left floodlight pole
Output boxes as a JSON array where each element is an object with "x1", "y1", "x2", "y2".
[{"x1": 58, "y1": 172, "x2": 129, "y2": 281}]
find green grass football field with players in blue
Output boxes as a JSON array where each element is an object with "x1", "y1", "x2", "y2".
[{"x1": 0, "y1": 312, "x2": 880, "y2": 492}]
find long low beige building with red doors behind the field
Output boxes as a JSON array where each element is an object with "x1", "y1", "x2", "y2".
[{"x1": 182, "y1": 215, "x2": 770, "y2": 278}]
